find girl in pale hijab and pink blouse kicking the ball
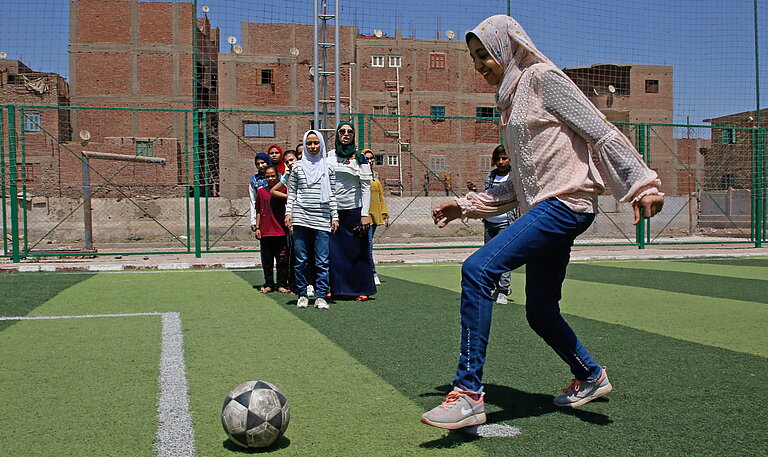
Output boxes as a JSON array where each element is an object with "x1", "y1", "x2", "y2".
[{"x1": 422, "y1": 15, "x2": 664, "y2": 429}]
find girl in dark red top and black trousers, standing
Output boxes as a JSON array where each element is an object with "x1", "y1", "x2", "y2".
[{"x1": 256, "y1": 166, "x2": 290, "y2": 294}]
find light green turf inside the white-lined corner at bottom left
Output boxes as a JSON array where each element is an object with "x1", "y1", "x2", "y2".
[{"x1": 0, "y1": 316, "x2": 160, "y2": 457}]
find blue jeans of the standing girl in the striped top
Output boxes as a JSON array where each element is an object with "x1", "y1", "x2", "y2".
[{"x1": 293, "y1": 225, "x2": 331, "y2": 297}]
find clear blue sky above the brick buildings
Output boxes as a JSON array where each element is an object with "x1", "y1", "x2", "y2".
[{"x1": 0, "y1": 0, "x2": 768, "y2": 130}]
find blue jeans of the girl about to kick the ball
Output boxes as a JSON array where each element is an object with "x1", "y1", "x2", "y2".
[{"x1": 454, "y1": 198, "x2": 602, "y2": 392}]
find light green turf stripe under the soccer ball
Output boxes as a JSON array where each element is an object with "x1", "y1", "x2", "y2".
[{"x1": 27, "y1": 271, "x2": 484, "y2": 456}]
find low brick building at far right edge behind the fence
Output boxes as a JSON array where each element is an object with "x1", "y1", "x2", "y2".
[{"x1": 704, "y1": 108, "x2": 768, "y2": 190}]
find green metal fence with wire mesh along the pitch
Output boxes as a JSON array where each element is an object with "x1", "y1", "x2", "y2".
[{"x1": 0, "y1": 105, "x2": 768, "y2": 262}]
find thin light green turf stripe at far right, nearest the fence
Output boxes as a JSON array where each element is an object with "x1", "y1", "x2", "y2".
[{"x1": 574, "y1": 259, "x2": 768, "y2": 281}]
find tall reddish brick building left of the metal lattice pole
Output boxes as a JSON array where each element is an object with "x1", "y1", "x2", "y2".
[{"x1": 63, "y1": 0, "x2": 219, "y2": 195}]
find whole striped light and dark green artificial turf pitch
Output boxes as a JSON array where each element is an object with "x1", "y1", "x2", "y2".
[{"x1": 0, "y1": 259, "x2": 768, "y2": 456}]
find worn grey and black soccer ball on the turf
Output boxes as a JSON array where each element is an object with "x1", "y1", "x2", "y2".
[{"x1": 221, "y1": 381, "x2": 291, "y2": 448}]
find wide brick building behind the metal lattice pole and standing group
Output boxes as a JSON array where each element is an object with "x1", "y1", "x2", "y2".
[{"x1": 219, "y1": 23, "x2": 498, "y2": 197}]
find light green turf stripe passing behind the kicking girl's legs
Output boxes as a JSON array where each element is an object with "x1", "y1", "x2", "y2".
[{"x1": 380, "y1": 261, "x2": 768, "y2": 357}]
